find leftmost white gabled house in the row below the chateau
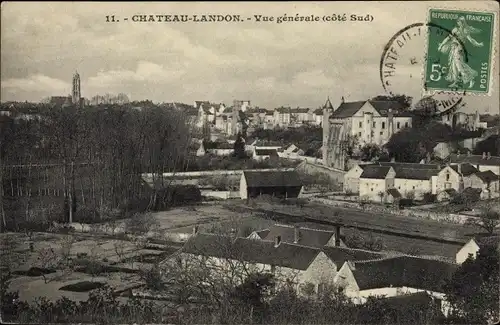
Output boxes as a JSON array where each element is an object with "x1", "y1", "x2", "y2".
[{"x1": 359, "y1": 165, "x2": 396, "y2": 203}]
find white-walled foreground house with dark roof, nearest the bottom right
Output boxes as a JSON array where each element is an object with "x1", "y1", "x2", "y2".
[{"x1": 334, "y1": 256, "x2": 458, "y2": 303}]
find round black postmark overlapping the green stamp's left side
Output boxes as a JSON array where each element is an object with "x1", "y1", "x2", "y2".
[{"x1": 380, "y1": 23, "x2": 468, "y2": 116}]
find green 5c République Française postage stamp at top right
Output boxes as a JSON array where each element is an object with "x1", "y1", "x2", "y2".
[{"x1": 424, "y1": 9, "x2": 496, "y2": 94}]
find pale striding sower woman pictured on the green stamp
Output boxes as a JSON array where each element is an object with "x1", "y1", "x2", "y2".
[{"x1": 438, "y1": 16, "x2": 483, "y2": 88}]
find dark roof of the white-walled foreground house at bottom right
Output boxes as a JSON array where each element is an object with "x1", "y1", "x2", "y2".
[{"x1": 352, "y1": 256, "x2": 458, "y2": 292}]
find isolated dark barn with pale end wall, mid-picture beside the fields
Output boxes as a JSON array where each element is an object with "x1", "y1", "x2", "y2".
[{"x1": 240, "y1": 170, "x2": 304, "y2": 199}]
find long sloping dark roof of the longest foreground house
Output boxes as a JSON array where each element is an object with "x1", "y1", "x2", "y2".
[{"x1": 182, "y1": 234, "x2": 320, "y2": 270}]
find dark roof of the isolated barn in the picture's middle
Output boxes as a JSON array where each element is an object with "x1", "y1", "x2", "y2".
[{"x1": 243, "y1": 170, "x2": 304, "y2": 187}]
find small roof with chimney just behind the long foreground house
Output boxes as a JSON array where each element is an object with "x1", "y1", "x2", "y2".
[{"x1": 265, "y1": 225, "x2": 335, "y2": 248}]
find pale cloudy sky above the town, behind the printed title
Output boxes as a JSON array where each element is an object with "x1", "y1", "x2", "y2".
[{"x1": 1, "y1": 1, "x2": 499, "y2": 113}]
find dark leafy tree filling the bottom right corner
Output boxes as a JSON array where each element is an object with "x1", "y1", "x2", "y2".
[{"x1": 445, "y1": 246, "x2": 500, "y2": 324}]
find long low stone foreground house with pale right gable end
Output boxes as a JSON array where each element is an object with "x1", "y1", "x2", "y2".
[{"x1": 170, "y1": 233, "x2": 336, "y2": 292}]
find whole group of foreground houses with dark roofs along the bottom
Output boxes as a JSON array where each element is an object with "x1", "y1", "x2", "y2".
[{"x1": 162, "y1": 224, "x2": 499, "y2": 315}]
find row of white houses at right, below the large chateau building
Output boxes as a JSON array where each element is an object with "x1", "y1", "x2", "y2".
[{"x1": 344, "y1": 153, "x2": 500, "y2": 203}]
